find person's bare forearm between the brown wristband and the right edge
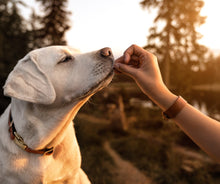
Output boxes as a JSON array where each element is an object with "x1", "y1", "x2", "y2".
[{"x1": 174, "y1": 104, "x2": 220, "y2": 162}]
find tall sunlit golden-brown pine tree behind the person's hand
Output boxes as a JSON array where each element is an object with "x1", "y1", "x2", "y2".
[{"x1": 141, "y1": 0, "x2": 207, "y2": 86}]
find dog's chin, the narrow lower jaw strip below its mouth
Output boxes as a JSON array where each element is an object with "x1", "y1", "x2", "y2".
[{"x1": 77, "y1": 69, "x2": 114, "y2": 100}]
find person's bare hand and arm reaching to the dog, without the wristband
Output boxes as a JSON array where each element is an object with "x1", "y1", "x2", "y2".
[{"x1": 114, "y1": 45, "x2": 220, "y2": 163}]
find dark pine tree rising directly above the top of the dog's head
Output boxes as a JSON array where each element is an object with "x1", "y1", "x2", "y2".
[{"x1": 37, "y1": 0, "x2": 70, "y2": 46}]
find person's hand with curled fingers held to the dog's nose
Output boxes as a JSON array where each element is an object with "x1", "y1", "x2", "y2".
[{"x1": 114, "y1": 45, "x2": 165, "y2": 97}]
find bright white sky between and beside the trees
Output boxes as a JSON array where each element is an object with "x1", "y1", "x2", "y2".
[{"x1": 24, "y1": 0, "x2": 220, "y2": 55}]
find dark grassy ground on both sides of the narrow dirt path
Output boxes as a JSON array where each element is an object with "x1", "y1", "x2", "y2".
[{"x1": 75, "y1": 89, "x2": 219, "y2": 184}]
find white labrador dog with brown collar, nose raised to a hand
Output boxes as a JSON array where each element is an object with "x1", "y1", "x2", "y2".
[{"x1": 0, "y1": 46, "x2": 114, "y2": 184}]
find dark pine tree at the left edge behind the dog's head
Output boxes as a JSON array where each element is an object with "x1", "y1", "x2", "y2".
[{"x1": 0, "y1": 0, "x2": 28, "y2": 77}]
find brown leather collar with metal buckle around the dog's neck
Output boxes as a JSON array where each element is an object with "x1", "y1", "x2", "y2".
[{"x1": 8, "y1": 111, "x2": 53, "y2": 155}]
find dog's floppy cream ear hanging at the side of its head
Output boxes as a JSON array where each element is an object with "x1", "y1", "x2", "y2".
[{"x1": 3, "y1": 54, "x2": 56, "y2": 104}]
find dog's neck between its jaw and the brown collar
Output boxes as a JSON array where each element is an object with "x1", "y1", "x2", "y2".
[{"x1": 11, "y1": 97, "x2": 89, "y2": 149}]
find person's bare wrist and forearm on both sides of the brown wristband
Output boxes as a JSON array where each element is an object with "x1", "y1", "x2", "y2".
[{"x1": 148, "y1": 84, "x2": 220, "y2": 162}]
